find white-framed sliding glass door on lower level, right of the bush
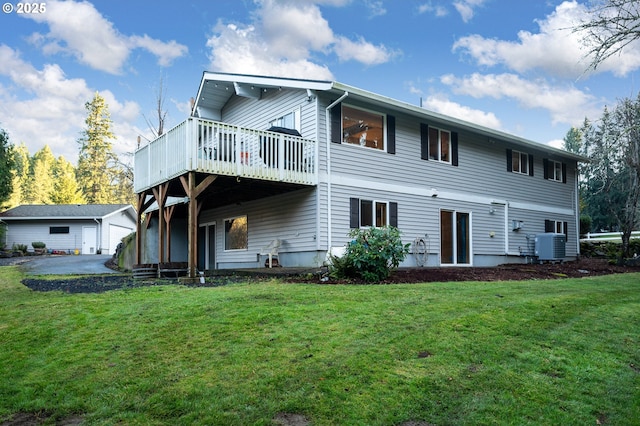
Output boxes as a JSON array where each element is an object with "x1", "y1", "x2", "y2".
[{"x1": 440, "y1": 210, "x2": 471, "y2": 265}]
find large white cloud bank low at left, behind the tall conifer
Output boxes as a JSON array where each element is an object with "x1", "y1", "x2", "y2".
[{"x1": 0, "y1": 45, "x2": 140, "y2": 162}]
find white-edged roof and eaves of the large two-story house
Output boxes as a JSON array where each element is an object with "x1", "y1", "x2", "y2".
[{"x1": 192, "y1": 72, "x2": 589, "y2": 162}]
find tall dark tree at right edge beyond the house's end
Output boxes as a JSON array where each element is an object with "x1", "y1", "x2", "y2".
[{"x1": 582, "y1": 96, "x2": 640, "y2": 257}]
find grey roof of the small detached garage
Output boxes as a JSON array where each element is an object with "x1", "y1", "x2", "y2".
[{"x1": 0, "y1": 204, "x2": 135, "y2": 221}]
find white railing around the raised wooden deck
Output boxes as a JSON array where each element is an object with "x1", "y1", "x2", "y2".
[{"x1": 134, "y1": 118, "x2": 318, "y2": 192}]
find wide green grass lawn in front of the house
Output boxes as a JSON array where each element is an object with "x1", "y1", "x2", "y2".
[{"x1": 0, "y1": 267, "x2": 640, "y2": 425}]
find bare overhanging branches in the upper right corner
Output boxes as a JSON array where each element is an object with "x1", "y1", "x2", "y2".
[{"x1": 573, "y1": 0, "x2": 640, "y2": 70}]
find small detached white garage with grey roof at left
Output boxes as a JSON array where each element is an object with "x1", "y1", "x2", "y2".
[{"x1": 0, "y1": 204, "x2": 136, "y2": 254}]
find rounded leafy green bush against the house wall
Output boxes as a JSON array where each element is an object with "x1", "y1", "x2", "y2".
[{"x1": 330, "y1": 227, "x2": 410, "y2": 282}]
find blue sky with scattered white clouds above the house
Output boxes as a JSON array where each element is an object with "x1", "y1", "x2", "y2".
[{"x1": 0, "y1": 0, "x2": 640, "y2": 163}]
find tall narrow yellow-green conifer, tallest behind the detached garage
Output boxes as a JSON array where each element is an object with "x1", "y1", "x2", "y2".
[{"x1": 76, "y1": 93, "x2": 117, "y2": 204}]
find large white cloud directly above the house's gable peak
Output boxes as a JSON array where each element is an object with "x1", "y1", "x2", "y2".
[{"x1": 207, "y1": 0, "x2": 397, "y2": 80}]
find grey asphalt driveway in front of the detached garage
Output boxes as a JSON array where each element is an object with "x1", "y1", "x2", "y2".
[{"x1": 22, "y1": 254, "x2": 118, "y2": 275}]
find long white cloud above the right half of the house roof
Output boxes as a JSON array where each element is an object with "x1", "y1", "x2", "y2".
[{"x1": 441, "y1": 73, "x2": 597, "y2": 125}]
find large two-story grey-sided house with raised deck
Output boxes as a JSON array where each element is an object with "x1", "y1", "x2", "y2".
[{"x1": 135, "y1": 72, "x2": 585, "y2": 276}]
